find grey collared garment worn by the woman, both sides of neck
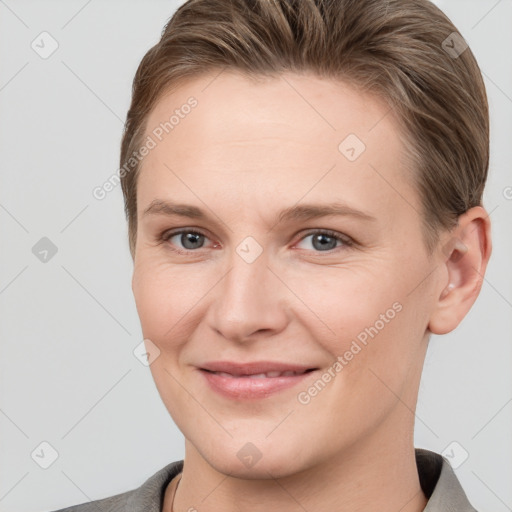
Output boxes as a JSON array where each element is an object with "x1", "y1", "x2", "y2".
[{"x1": 48, "y1": 448, "x2": 476, "y2": 512}]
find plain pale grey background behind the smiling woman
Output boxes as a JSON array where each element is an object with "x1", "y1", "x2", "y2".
[{"x1": 0, "y1": 0, "x2": 512, "y2": 512}]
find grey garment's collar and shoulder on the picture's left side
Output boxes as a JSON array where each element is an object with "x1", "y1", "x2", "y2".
[{"x1": 46, "y1": 460, "x2": 183, "y2": 512}]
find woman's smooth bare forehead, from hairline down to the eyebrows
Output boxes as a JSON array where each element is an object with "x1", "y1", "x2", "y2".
[{"x1": 138, "y1": 72, "x2": 416, "y2": 222}]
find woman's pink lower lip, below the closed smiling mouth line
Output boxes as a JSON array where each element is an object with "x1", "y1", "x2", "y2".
[{"x1": 201, "y1": 370, "x2": 315, "y2": 399}]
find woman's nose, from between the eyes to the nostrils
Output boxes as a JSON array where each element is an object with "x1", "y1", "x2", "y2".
[{"x1": 208, "y1": 245, "x2": 291, "y2": 342}]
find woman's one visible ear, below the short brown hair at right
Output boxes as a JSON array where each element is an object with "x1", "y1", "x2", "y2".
[{"x1": 428, "y1": 206, "x2": 491, "y2": 334}]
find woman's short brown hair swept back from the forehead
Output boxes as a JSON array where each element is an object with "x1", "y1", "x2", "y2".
[{"x1": 120, "y1": 0, "x2": 489, "y2": 257}]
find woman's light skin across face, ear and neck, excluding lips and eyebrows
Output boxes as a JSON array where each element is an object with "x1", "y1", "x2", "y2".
[{"x1": 132, "y1": 71, "x2": 491, "y2": 512}]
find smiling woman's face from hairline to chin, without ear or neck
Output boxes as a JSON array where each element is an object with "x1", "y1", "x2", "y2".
[{"x1": 133, "y1": 72, "x2": 442, "y2": 477}]
